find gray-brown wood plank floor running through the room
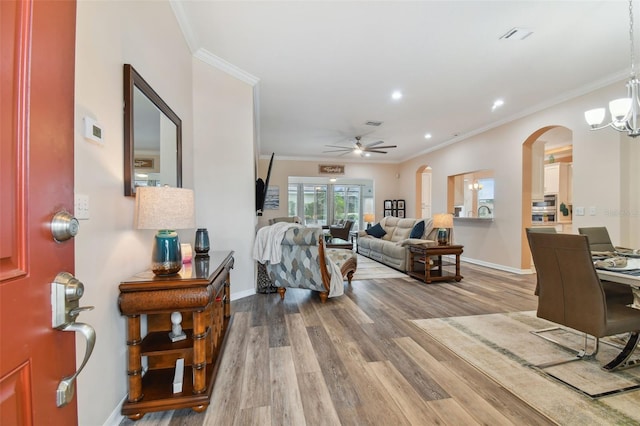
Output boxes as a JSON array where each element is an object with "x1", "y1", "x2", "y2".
[{"x1": 123, "y1": 263, "x2": 554, "y2": 426}]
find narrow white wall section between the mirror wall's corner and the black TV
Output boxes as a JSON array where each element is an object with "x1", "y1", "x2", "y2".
[{"x1": 193, "y1": 59, "x2": 255, "y2": 298}]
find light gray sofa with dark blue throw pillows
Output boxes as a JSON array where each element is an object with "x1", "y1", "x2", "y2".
[{"x1": 358, "y1": 216, "x2": 438, "y2": 272}]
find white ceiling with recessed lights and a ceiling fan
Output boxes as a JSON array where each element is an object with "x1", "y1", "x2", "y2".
[{"x1": 172, "y1": 0, "x2": 640, "y2": 162}]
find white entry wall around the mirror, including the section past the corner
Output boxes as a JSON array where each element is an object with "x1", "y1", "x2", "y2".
[{"x1": 75, "y1": 0, "x2": 255, "y2": 426}]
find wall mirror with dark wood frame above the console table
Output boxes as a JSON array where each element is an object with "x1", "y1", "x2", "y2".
[{"x1": 124, "y1": 64, "x2": 182, "y2": 196}]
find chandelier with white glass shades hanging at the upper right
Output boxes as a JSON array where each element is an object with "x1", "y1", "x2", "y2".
[{"x1": 584, "y1": 0, "x2": 640, "y2": 138}]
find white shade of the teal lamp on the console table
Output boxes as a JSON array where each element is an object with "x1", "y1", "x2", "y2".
[{"x1": 134, "y1": 186, "x2": 196, "y2": 230}]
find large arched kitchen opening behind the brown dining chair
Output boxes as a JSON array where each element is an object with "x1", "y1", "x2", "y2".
[{"x1": 520, "y1": 126, "x2": 573, "y2": 270}]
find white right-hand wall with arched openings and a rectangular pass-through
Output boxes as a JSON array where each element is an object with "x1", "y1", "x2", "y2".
[{"x1": 400, "y1": 82, "x2": 640, "y2": 271}]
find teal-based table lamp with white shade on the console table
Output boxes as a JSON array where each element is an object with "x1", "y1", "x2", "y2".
[{"x1": 134, "y1": 186, "x2": 196, "y2": 275}]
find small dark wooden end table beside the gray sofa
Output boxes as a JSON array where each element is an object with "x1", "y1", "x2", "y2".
[{"x1": 407, "y1": 244, "x2": 464, "y2": 284}]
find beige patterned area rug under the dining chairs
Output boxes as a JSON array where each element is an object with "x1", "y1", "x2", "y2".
[{"x1": 413, "y1": 312, "x2": 640, "y2": 425}]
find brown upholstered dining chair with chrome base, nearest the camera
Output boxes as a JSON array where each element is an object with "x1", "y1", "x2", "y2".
[{"x1": 527, "y1": 232, "x2": 640, "y2": 371}]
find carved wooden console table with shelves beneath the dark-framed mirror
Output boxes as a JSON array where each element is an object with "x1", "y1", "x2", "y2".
[{"x1": 118, "y1": 251, "x2": 234, "y2": 420}]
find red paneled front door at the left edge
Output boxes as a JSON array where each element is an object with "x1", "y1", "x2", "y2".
[{"x1": 0, "y1": 0, "x2": 78, "y2": 425}]
